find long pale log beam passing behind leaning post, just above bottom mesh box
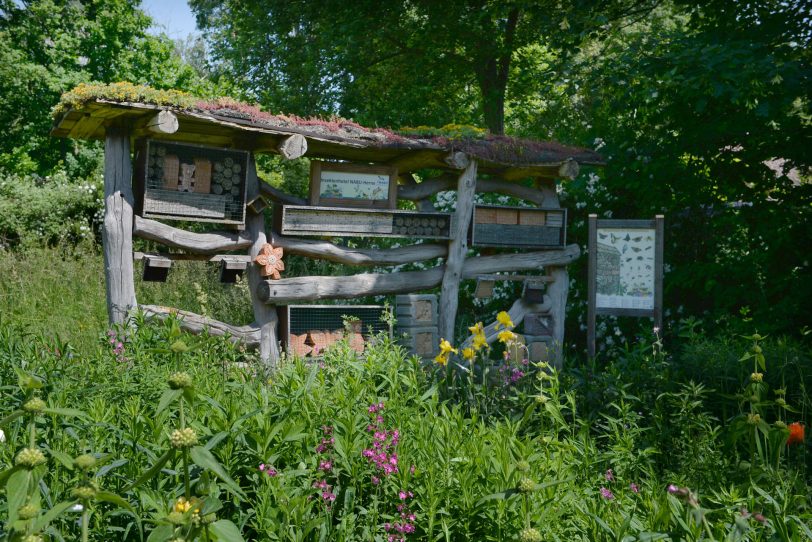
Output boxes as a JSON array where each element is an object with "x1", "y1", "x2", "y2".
[{"x1": 257, "y1": 244, "x2": 581, "y2": 305}]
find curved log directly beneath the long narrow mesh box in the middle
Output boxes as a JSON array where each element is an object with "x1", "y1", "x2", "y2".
[{"x1": 269, "y1": 232, "x2": 448, "y2": 265}]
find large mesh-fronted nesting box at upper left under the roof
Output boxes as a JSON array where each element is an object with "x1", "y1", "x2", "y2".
[{"x1": 138, "y1": 140, "x2": 248, "y2": 225}]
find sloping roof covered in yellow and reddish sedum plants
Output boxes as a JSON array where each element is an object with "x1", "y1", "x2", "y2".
[{"x1": 52, "y1": 83, "x2": 603, "y2": 176}]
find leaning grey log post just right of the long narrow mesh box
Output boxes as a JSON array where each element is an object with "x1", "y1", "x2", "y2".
[{"x1": 439, "y1": 159, "x2": 477, "y2": 342}]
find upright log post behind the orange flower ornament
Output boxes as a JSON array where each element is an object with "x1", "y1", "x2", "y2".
[{"x1": 245, "y1": 155, "x2": 279, "y2": 371}]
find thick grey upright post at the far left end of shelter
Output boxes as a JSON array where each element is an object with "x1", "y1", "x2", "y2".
[{"x1": 102, "y1": 125, "x2": 136, "y2": 324}]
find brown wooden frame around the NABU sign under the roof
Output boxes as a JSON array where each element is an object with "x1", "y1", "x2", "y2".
[{"x1": 310, "y1": 160, "x2": 398, "y2": 209}]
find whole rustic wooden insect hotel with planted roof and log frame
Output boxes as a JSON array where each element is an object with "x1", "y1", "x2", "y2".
[{"x1": 47, "y1": 84, "x2": 601, "y2": 367}]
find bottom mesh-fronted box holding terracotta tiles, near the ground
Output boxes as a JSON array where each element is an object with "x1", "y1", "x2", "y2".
[{"x1": 281, "y1": 305, "x2": 392, "y2": 357}]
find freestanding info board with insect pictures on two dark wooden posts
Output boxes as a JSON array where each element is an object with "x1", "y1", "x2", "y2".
[{"x1": 587, "y1": 214, "x2": 665, "y2": 358}]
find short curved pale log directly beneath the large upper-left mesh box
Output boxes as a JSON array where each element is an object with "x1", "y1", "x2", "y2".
[{"x1": 133, "y1": 216, "x2": 251, "y2": 254}]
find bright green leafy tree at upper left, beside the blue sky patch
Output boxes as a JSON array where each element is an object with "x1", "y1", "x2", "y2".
[{"x1": 0, "y1": 0, "x2": 202, "y2": 173}]
